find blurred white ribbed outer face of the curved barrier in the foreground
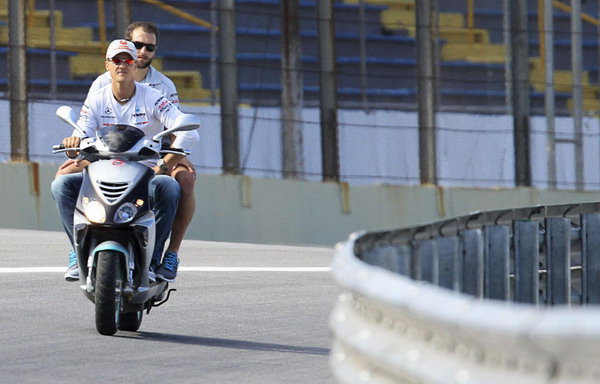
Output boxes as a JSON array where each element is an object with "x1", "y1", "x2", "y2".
[{"x1": 330, "y1": 233, "x2": 600, "y2": 384}]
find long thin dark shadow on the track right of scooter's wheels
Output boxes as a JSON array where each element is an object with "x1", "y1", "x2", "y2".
[{"x1": 114, "y1": 332, "x2": 329, "y2": 355}]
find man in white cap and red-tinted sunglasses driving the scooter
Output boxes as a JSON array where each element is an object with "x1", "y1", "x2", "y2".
[{"x1": 52, "y1": 40, "x2": 199, "y2": 281}]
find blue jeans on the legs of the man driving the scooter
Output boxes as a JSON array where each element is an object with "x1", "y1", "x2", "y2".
[{"x1": 51, "y1": 173, "x2": 180, "y2": 265}]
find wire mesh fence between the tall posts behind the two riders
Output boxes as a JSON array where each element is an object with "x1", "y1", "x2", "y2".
[{"x1": 0, "y1": 0, "x2": 600, "y2": 189}]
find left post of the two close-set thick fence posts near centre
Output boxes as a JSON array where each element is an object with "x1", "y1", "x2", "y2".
[{"x1": 281, "y1": 0, "x2": 304, "y2": 178}]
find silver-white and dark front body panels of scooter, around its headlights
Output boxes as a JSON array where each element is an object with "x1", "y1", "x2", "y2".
[{"x1": 74, "y1": 159, "x2": 166, "y2": 312}]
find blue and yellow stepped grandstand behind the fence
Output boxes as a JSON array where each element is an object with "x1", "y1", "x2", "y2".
[{"x1": 0, "y1": 0, "x2": 600, "y2": 114}]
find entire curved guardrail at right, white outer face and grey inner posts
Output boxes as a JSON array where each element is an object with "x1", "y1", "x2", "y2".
[{"x1": 331, "y1": 203, "x2": 600, "y2": 384}]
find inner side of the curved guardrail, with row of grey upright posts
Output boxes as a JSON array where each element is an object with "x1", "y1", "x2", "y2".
[{"x1": 355, "y1": 203, "x2": 600, "y2": 305}]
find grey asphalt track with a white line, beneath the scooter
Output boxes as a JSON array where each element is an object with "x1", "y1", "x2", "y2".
[{"x1": 0, "y1": 229, "x2": 339, "y2": 384}]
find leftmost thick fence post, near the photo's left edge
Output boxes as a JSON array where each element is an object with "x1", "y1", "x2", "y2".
[{"x1": 8, "y1": 0, "x2": 29, "y2": 161}]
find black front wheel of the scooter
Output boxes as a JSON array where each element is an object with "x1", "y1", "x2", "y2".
[{"x1": 94, "y1": 251, "x2": 123, "y2": 336}]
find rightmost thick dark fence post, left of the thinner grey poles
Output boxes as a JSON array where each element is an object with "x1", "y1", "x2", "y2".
[{"x1": 510, "y1": 0, "x2": 531, "y2": 186}]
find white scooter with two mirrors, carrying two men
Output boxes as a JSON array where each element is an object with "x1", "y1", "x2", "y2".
[{"x1": 53, "y1": 106, "x2": 200, "y2": 335}]
